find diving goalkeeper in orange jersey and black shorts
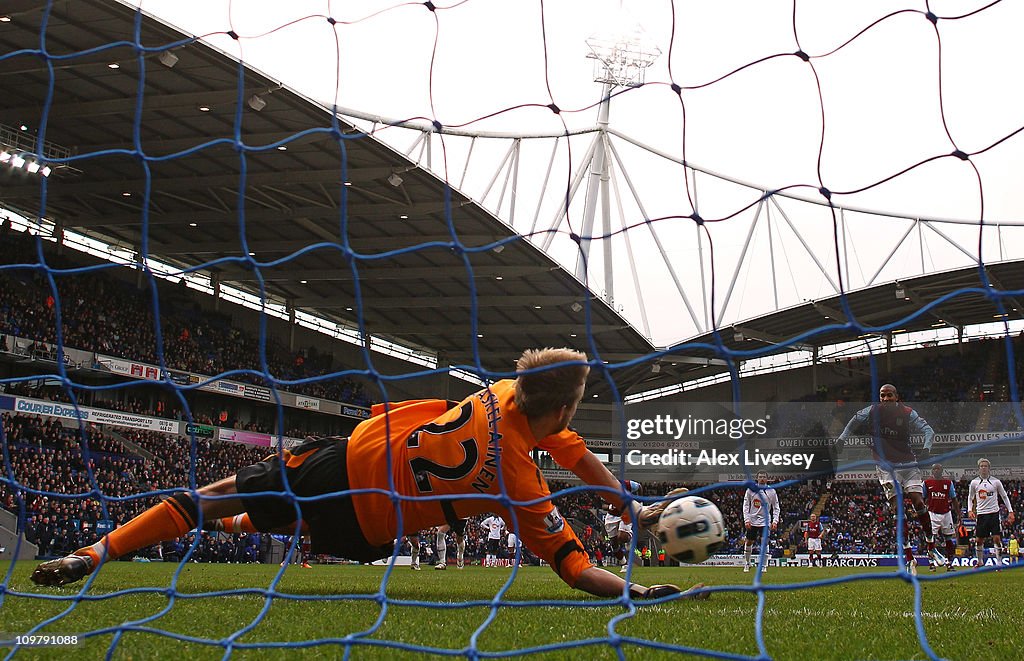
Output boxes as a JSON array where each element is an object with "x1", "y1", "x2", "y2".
[{"x1": 32, "y1": 349, "x2": 707, "y2": 599}]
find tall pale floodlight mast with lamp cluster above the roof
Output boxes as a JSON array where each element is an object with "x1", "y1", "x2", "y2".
[{"x1": 577, "y1": 15, "x2": 662, "y2": 304}]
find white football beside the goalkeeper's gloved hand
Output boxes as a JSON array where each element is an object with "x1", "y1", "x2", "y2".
[{"x1": 657, "y1": 496, "x2": 725, "y2": 565}]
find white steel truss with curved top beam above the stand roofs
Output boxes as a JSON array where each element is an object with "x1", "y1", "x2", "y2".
[{"x1": 336, "y1": 104, "x2": 1024, "y2": 346}]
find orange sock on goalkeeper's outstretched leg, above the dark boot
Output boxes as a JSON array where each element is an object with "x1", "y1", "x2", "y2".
[{"x1": 75, "y1": 493, "x2": 199, "y2": 567}]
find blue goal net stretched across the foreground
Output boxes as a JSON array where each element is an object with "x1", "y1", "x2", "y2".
[{"x1": 0, "y1": 2, "x2": 1024, "y2": 658}]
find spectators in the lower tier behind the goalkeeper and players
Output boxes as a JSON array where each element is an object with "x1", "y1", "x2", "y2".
[{"x1": 0, "y1": 412, "x2": 1024, "y2": 562}]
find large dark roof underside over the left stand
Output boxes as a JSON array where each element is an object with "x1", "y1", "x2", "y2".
[{"x1": 0, "y1": 0, "x2": 688, "y2": 388}]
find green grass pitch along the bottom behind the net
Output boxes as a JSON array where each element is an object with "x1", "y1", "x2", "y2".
[{"x1": 0, "y1": 563, "x2": 1024, "y2": 661}]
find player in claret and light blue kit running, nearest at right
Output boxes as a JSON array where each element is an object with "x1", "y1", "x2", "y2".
[{"x1": 839, "y1": 384, "x2": 945, "y2": 575}]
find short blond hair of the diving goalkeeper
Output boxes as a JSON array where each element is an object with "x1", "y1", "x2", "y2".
[{"x1": 515, "y1": 349, "x2": 590, "y2": 417}]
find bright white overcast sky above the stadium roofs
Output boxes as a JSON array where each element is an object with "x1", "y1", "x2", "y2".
[{"x1": 128, "y1": 0, "x2": 1024, "y2": 345}]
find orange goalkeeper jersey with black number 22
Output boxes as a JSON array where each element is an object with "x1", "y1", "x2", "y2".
[{"x1": 347, "y1": 380, "x2": 592, "y2": 585}]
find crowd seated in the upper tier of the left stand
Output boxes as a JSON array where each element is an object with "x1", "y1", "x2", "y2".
[{"x1": 0, "y1": 224, "x2": 372, "y2": 406}]
